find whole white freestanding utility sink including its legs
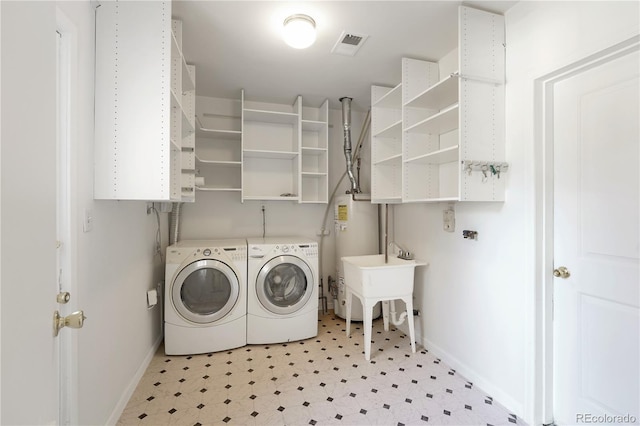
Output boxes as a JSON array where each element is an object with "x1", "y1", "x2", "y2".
[{"x1": 342, "y1": 254, "x2": 427, "y2": 361}]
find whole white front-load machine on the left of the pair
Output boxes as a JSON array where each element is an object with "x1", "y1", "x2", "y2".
[{"x1": 164, "y1": 239, "x2": 247, "y2": 355}]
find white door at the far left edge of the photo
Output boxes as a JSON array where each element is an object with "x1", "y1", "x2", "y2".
[{"x1": 0, "y1": 2, "x2": 59, "y2": 425}]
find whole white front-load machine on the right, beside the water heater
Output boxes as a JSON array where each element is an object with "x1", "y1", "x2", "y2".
[{"x1": 247, "y1": 237, "x2": 319, "y2": 343}]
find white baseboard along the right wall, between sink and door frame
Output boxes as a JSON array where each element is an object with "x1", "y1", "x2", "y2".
[{"x1": 416, "y1": 336, "x2": 524, "y2": 418}]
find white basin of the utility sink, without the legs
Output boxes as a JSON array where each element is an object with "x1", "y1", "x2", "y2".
[{"x1": 342, "y1": 254, "x2": 427, "y2": 299}]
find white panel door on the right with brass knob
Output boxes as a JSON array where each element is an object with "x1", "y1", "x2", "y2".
[{"x1": 553, "y1": 46, "x2": 640, "y2": 424}]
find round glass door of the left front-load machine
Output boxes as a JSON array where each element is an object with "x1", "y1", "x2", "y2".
[{"x1": 171, "y1": 259, "x2": 240, "y2": 324}]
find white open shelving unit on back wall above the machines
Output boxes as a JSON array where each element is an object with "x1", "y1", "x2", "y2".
[{"x1": 196, "y1": 91, "x2": 329, "y2": 203}]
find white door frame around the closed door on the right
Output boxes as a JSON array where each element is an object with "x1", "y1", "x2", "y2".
[{"x1": 533, "y1": 36, "x2": 640, "y2": 425}]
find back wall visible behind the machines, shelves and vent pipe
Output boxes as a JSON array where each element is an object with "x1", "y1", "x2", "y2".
[{"x1": 179, "y1": 101, "x2": 371, "y2": 307}]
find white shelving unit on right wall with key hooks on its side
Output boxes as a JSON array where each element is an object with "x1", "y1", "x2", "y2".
[{"x1": 372, "y1": 6, "x2": 508, "y2": 203}]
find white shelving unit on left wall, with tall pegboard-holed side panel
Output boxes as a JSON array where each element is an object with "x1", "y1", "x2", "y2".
[{"x1": 94, "y1": 2, "x2": 195, "y2": 201}]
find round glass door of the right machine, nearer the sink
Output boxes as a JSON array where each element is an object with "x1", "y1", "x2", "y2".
[{"x1": 256, "y1": 256, "x2": 314, "y2": 315}]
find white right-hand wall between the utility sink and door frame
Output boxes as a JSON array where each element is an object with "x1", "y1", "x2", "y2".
[{"x1": 394, "y1": 1, "x2": 639, "y2": 422}]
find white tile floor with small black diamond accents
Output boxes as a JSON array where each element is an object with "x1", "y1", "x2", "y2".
[{"x1": 118, "y1": 313, "x2": 525, "y2": 426}]
